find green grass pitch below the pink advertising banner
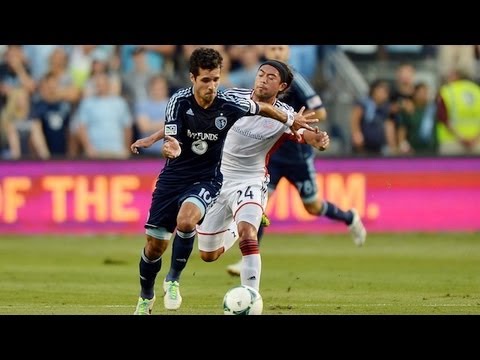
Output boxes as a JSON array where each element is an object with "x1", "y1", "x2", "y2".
[{"x1": 0, "y1": 229, "x2": 480, "y2": 315}]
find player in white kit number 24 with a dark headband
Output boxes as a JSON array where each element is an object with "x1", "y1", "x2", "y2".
[{"x1": 197, "y1": 60, "x2": 329, "y2": 290}]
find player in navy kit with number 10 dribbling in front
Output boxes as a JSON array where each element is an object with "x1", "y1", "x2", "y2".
[{"x1": 132, "y1": 48, "x2": 316, "y2": 315}]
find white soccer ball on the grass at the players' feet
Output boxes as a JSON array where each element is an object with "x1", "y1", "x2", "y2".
[{"x1": 223, "y1": 285, "x2": 263, "y2": 315}]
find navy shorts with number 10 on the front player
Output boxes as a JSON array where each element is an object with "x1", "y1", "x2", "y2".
[{"x1": 145, "y1": 178, "x2": 222, "y2": 232}]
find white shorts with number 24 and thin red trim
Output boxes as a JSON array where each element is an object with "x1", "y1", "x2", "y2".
[{"x1": 197, "y1": 176, "x2": 269, "y2": 252}]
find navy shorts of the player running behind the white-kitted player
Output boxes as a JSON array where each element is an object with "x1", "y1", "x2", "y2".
[{"x1": 268, "y1": 157, "x2": 317, "y2": 203}]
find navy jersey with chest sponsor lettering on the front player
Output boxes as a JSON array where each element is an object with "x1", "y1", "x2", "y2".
[{"x1": 160, "y1": 87, "x2": 259, "y2": 185}]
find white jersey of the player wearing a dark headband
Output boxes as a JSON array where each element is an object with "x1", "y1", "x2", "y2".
[{"x1": 221, "y1": 89, "x2": 294, "y2": 179}]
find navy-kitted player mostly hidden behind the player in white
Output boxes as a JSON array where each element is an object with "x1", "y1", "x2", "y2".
[{"x1": 227, "y1": 45, "x2": 367, "y2": 276}]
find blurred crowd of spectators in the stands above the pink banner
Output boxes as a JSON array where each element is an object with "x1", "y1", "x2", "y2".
[{"x1": 0, "y1": 45, "x2": 480, "y2": 160}]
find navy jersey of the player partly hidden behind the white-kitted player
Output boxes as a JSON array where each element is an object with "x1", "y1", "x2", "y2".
[{"x1": 271, "y1": 71, "x2": 323, "y2": 164}]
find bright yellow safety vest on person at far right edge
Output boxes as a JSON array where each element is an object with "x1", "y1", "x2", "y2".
[{"x1": 437, "y1": 80, "x2": 480, "y2": 144}]
